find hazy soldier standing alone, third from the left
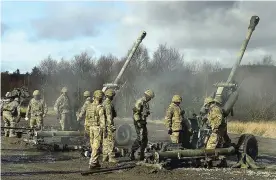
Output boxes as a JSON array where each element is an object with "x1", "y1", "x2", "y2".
[{"x1": 54, "y1": 87, "x2": 72, "y2": 131}]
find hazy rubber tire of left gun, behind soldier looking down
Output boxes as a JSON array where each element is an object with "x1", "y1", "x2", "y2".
[{"x1": 115, "y1": 124, "x2": 132, "y2": 146}]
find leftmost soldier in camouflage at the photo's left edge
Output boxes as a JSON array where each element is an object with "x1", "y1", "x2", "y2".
[{"x1": 3, "y1": 97, "x2": 20, "y2": 137}]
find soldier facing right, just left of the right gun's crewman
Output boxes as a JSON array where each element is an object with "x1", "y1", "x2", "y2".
[{"x1": 165, "y1": 95, "x2": 192, "y2": 147}]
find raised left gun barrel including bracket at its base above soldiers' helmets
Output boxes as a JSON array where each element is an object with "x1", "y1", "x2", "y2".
[{"x1": 102, "y1": 31, "x2": 147, "y2": 92}]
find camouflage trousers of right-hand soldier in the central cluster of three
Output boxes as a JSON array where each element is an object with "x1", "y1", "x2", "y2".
[{"x1": 102, "y1": 129, "x2": 115, "y2": 161}]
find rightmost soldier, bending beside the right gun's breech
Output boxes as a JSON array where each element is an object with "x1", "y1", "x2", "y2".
[{"x1": 206, "y1": 98, "x2": 231, "y2": 149}]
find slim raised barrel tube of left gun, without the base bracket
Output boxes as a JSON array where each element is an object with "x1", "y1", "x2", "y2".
[{"x1": 113, "y1": 31, "x2": 147, "y2": 84}]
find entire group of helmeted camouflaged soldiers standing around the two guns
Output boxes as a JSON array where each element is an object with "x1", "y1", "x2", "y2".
[{"x1": 3, "y1": 87, "x2": 231, "y2": 169}]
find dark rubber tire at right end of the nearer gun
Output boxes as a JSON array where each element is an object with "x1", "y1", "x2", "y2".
[{"x1": 237, "y1": 134, "x2": 258, "y2": 161}]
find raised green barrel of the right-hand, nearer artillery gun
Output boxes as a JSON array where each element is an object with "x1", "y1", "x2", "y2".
[{"x1": 227, "y1": 16, "x2": 260, "y2": 83}]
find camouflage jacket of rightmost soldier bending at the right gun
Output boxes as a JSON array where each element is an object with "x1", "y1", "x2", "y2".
[{"x1": 207, "y1": 104, "x2": 226, "y2": 130}]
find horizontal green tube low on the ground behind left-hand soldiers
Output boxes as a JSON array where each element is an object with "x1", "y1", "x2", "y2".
[{"x1": 34, "y1": 131, "x2": 84, "y2": 138}]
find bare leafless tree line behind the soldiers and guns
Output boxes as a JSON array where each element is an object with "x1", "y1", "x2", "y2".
[{"x1": 1, "y1": 44, "x2": 276, "y2": 120}]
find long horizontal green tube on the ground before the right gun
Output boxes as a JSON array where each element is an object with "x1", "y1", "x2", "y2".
[{"x1": 154, "y1": 146, "x2": 236, "y2": 163}]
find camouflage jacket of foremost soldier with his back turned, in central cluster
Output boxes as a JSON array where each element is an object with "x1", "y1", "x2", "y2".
[{"x1": 85, "y1": 101, "x2": 106, "y2": 128}]
